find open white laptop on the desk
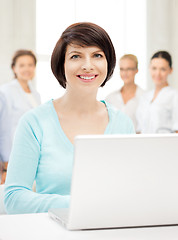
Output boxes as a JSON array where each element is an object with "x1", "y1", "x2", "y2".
[{"x1": 49, "y1": 134, "x2": 178, "y2": 230}]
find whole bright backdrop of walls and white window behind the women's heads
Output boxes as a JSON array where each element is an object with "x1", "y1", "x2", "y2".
[{"x1": 0, "y1": 0, "x2": 178, "y2": 102}]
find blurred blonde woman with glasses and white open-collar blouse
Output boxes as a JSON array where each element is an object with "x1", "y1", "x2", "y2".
[{"x1": 106, "y1": 54, "x2": 144, "y2": 128}]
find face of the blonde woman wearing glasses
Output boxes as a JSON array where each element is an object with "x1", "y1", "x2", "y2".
[{"x1": 119, "y1": 58, "x2": 138, "y2": 84}]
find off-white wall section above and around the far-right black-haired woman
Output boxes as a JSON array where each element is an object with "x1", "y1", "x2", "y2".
[{"x1": 147, "y1": 0, "x2": 178, "y2": 89}]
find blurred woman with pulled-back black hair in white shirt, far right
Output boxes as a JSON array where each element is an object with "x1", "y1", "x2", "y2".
[{"x1": 137, "y1": 51, "x2": 178, "y2": 133}]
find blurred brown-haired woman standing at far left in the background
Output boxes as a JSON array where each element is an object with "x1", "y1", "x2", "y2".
[{"x1": 0, "y1": 50, "x2": 40, "y2": 183}]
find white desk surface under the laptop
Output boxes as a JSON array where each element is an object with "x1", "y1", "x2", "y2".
[{"x1": 0, "y1": 213, "x2": 178, "y2": 240}]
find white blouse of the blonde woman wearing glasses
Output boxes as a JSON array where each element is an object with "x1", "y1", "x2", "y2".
[{"x1": 106, "y1": 86, "x2": 144, "y2": 129}]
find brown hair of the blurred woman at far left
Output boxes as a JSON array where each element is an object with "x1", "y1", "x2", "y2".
[{"x1": 11, "y1": 49, "x2": 37, "y2": 78}]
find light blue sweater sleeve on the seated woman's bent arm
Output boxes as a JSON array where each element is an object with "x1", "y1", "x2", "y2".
[{"x1": 4, "y1": 114, "x2": 69, "y2": 214}]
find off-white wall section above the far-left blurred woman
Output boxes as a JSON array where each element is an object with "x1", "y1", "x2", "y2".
[{"x1": 0, "y1": 0, "x2": 36, "y2": 85}]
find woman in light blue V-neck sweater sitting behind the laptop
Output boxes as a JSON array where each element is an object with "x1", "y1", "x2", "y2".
[{"x1": 5, "y1": 23, "x2": 134, "y2": 213}]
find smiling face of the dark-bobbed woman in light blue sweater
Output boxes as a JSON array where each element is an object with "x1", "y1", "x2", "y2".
[{"x1": 64, "y1": 44, "x2": 108, "y2": 94}]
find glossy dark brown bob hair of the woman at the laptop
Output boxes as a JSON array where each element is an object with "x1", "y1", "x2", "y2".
[{"x1": 51, "y1": 22, "x2": 116, "y2": 88}]
